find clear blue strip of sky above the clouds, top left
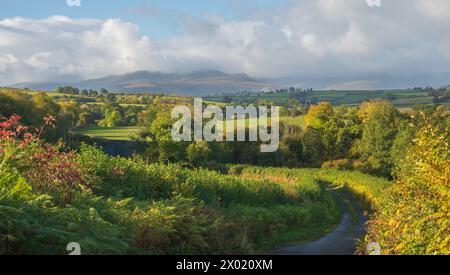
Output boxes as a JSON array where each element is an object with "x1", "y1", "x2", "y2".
[{"x1": 0, "y1": 0, "x2": 287, "y2": 39}]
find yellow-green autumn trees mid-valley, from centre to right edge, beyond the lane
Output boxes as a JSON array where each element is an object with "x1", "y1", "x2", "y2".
[{"x1": 139, "y1": 100, "x2": 450, "y2": 178}]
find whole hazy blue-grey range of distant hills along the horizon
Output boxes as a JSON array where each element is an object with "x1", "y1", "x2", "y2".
[{"x1": 12, "y1": 70, "x2": 450, "y2": 96}]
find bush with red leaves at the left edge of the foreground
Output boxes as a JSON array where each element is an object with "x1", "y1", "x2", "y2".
[{"x1": 0, "y1": 115, "x2": 87, "y2": 205}]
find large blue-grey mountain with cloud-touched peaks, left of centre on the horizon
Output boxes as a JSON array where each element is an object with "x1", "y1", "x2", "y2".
[{"x1": 13, "y1": 70, "x2": 271, "y2": 96}]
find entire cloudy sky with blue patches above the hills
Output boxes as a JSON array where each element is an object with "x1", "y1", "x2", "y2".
[{"x1": 0, "y1": 0, "x2": 450, "y2": 85}]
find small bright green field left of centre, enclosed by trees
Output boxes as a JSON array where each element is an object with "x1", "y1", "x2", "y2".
[{"x1": 75, "y1": 126, "x2": 142, "y2": 141}]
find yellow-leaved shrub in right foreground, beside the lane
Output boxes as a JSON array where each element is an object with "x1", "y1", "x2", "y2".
[{"x1": 367, "y1": 124, "x2": 450, "y2": 254}]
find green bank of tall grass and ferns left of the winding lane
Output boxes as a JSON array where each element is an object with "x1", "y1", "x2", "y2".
[{"x1": 0, "y1": 146, "x2": 339, "y2": 255}]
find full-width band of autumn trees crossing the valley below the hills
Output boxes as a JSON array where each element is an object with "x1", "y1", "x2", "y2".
[{"x1": 0, "y1": 88, "x2": 450, "y2": 177}]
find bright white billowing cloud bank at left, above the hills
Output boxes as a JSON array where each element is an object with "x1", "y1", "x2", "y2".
[{"x1": 0, "y1": 16, "x2": 165, "y2": 83}]
